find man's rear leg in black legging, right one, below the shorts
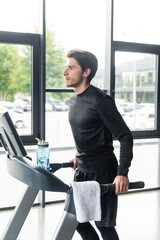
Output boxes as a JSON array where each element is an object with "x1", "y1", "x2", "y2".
[{"x1": 98, "y1": 227, "x2": 119, "y2": 240}]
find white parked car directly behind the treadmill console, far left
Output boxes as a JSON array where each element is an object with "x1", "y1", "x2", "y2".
[{"x1": 0, "y1": 106, "x2": 25, "y2": 129}]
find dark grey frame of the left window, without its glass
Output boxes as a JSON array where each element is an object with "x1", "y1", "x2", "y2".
[{"x1": 0, "y1": 31, "x2": 43, "y2": 145}]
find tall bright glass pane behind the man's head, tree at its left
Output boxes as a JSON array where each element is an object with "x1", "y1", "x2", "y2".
[{"x1": 46, "y1": 0, "x2": 106, "y2": 88}]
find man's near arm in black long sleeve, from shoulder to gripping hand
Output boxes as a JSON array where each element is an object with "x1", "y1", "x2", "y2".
[{"x1": 98, "y1": 96, "x2": 133, "y2": 194}]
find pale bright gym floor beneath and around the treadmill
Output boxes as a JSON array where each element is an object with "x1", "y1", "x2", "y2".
[{"x1": 0, "y1": 191, "x2": 160, "y2": 240}]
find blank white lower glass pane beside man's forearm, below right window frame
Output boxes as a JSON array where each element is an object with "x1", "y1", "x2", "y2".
[{"x1": 114, "y1": 139, "x2": 160, "y2": 189}]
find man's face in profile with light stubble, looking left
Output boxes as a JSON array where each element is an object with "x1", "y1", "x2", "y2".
[{"x1": 63, "y1": 58, "x2": 85, "y2": 88}]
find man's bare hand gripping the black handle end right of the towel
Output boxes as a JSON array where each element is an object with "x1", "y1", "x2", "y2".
[{"x1": 113, "y1": 176, "x2": 129, "y2": 194}]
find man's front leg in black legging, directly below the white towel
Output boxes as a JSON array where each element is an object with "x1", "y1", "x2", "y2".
[{"x1": 77, "y1": 222, "x2": 99, "y2": 240}]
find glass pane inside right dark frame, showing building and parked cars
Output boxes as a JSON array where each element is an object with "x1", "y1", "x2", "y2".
[{"x1": 115, "y1": 52, "x2": 157, "y2": 131}]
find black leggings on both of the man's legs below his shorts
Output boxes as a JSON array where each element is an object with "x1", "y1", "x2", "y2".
[{"x1": 77, "y1": 222, "x2": 119, "y2": 240}]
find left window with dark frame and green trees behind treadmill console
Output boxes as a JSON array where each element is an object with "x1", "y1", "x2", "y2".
[{"x1": 0, "y1": 32, "x2": 41, "y2": 144}]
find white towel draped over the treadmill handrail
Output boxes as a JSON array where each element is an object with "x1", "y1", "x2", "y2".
[{"x1": 71, "y1": 181, "x2": 101, "y2": 223}]
